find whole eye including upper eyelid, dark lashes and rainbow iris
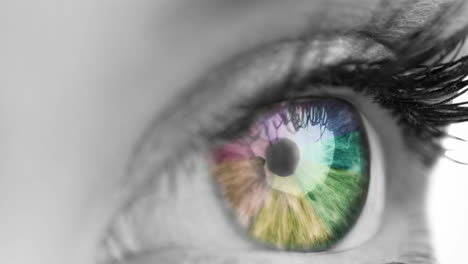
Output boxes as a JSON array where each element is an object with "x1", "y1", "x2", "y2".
[{"x1": 100, "y1": 27, "x2": 468, "y2": 264}]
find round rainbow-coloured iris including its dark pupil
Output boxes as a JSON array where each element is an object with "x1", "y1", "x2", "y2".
[{"x1": 213, "y1": 98, "x2": 369, "y2": 251}]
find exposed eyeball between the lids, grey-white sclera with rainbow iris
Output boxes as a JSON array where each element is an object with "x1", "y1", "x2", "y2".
[{"x1": 96, "y1": 89, "x2": 385, "y2": 263}]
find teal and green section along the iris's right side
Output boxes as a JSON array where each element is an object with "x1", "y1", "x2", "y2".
[{"x1": 307, "y1": 132, "x2": 369, "y2": 246}]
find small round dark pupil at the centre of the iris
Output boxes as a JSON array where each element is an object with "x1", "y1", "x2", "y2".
[{"x1": 266, "y1": 138, "x2": 299, "y2": 177}]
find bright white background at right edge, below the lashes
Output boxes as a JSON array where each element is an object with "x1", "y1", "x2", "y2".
[{"x1": 428, "y1": 93, "x2": 468, "y2": 264}]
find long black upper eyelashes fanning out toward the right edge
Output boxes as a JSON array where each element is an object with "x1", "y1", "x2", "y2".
[{"x1": 286, "y1": 28, "x2": 468, "y2": 162}]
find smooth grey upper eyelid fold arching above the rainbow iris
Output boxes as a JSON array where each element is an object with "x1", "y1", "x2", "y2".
[{"x1": 122, "y1": 34, "x2": 393, "y2": 201}]
